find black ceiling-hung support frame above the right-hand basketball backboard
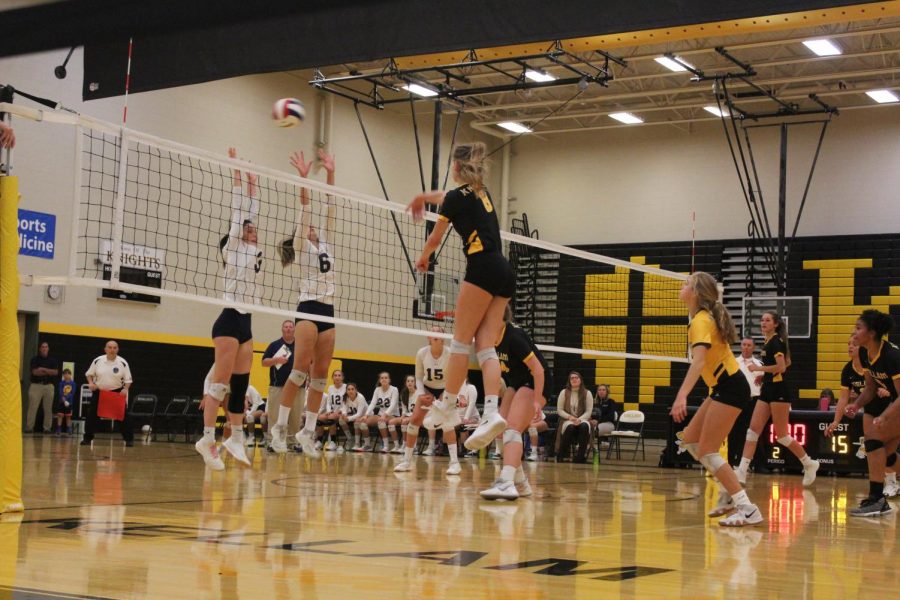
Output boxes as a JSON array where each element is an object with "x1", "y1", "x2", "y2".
[{"x1": 684, "y1": 46, "x2": 839, "y2": 296}]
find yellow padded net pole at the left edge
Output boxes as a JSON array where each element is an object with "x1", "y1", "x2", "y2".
[{"x1": 0, "y1": 171, "x2": 25, "y2": 514}]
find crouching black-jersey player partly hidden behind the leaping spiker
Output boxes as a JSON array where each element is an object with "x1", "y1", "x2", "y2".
[{"x1": 481, "y1": 308, "x2": 553, "y2": 500}]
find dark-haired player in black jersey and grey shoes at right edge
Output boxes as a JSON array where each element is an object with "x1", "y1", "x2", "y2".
[{"x1": 845, "y1": 309, "x2": 900, "y2": 517}]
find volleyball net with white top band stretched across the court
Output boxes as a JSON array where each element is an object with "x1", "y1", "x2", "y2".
[{"x1": 0, "y1": 104, "x2": 687, "y2": 362}]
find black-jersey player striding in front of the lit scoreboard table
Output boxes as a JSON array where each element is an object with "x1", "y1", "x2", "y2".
[{"x1": 735, "y1": 311, "x2": 819, "y2": 485}]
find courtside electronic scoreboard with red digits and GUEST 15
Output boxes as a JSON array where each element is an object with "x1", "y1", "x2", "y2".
[{"x1": 756, "y1": 410, "x2": 868, "y2": 473}]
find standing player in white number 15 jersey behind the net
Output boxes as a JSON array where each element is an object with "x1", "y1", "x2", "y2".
[{"x1": 394, "y1": 327, "x2": 462, "y2": 475}]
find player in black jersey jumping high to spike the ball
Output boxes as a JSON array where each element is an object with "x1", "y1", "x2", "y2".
[{"x1": 407, "y1": 142, "x2": 515, "y2": 450}]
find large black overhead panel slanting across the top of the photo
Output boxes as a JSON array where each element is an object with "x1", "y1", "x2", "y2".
[{"x1": 0, "y1": 0, "x2": 859, "y2": 100}]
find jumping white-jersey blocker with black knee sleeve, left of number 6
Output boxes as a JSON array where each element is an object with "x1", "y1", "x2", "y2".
[{"x1": 194, "y1": 148, "x2": 262, "y2": 470}]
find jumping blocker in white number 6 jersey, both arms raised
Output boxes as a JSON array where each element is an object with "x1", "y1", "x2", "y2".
[{"x1": 272, "y1": 148, "x2": 335, "y2": 458}]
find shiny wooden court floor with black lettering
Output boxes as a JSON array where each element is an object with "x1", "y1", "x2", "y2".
[{"x1": 0, "y1": 437, "x2": 900, "y2": 600}]
